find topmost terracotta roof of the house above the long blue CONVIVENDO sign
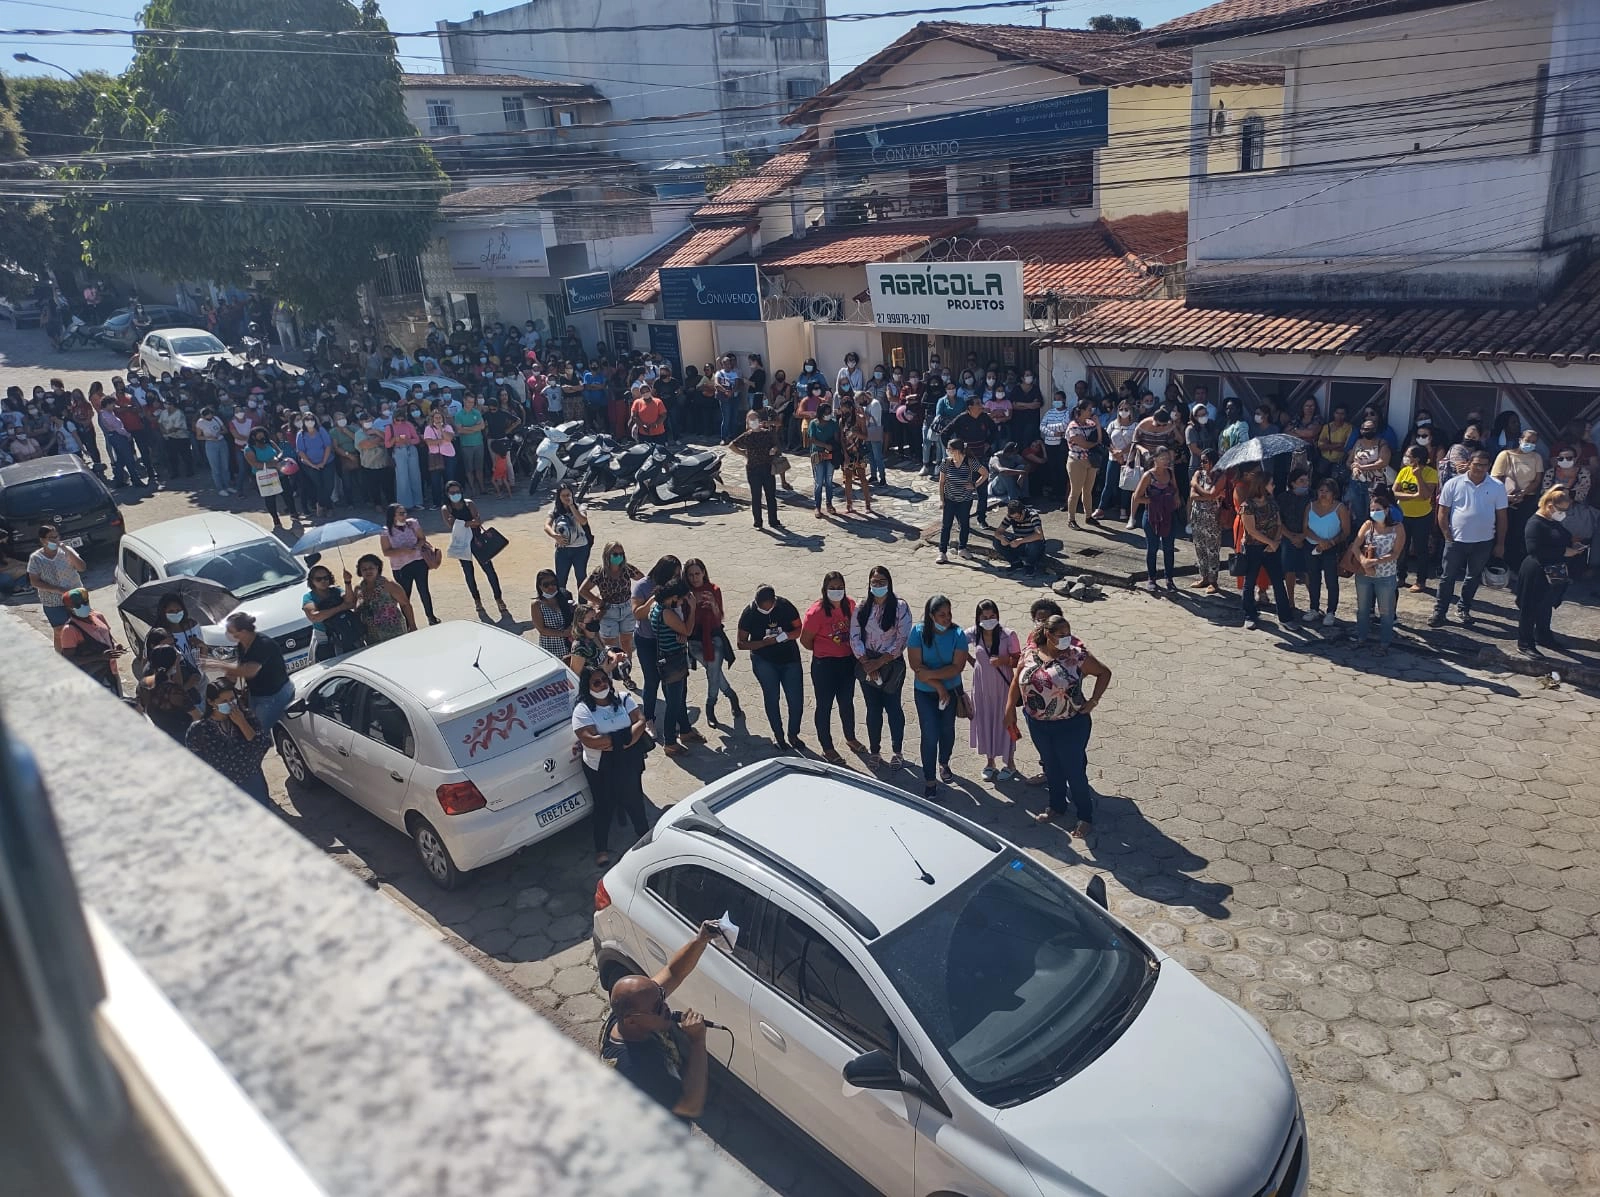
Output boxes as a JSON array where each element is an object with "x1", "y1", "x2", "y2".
[{"x1": 784, "y1": 21, "x2": 1283, "y2": 125}]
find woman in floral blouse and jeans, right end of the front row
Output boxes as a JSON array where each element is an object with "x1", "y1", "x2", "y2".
[{"x1": 1005, "y1": 615, "x2": 1110, "y2": 840}]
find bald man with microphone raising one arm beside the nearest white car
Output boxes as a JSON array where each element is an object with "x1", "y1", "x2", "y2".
[{"x1": 600, "y1": 922, "x2": 722, "y2": 1119}]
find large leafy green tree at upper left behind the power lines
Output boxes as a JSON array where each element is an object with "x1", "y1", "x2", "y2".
[{"x1": 82, "y1": 0, "x2": 446, "y2": 315}]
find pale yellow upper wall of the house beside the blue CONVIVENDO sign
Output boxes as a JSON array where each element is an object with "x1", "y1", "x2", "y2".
[{"x1": 1098, "y1": 83, "x2": 1283, "y2": 221}]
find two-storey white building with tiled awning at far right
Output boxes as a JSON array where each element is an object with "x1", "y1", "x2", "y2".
[{"x1": 1043, "y1": 0, "x2": 1600, "y2": 443}]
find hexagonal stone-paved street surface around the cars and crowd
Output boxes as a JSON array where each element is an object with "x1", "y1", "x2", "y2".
[{"x1": 0, "y1": 323, "x2": 1600, "y2": 1197}]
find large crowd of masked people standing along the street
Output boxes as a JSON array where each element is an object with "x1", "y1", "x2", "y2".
[{"x1": 9, "y1": 313, "x2": 1600, "y2": 825}]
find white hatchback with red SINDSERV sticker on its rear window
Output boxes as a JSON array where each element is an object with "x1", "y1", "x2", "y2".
[{"x1": 274, "y1": 621, "x2": 590, "y2": 890}]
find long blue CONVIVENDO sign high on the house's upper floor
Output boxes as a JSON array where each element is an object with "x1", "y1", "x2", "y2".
[{"x1": 834, "y1": 91, "x2": 1110, "y2": 171}]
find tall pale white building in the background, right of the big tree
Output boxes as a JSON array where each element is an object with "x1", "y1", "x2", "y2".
[{"x1": 438, "y1": 0, "x2": 827, "y2": 166}]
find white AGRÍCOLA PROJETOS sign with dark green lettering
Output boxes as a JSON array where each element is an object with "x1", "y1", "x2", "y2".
[{"x1": 867, "y1": 262, "x2": 1026, "y2": 333}]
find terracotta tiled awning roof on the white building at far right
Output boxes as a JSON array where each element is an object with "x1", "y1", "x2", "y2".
[{"x1": 1046, "y1": 262, "x2": 1600, "y2": 365}]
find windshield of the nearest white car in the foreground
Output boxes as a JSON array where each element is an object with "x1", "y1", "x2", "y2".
[{"x1": 872, "y1": 856, "x2": 1155, "y2": 1106}]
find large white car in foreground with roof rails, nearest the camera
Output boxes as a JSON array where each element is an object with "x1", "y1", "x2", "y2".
[{"x1": 594, "y1": 759, "x2": 1310, "y2": 1197}]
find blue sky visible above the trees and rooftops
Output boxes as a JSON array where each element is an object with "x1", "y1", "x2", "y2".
[{"x1": 0, "y1": 0, "x2": 1208, "y2": 78}]
